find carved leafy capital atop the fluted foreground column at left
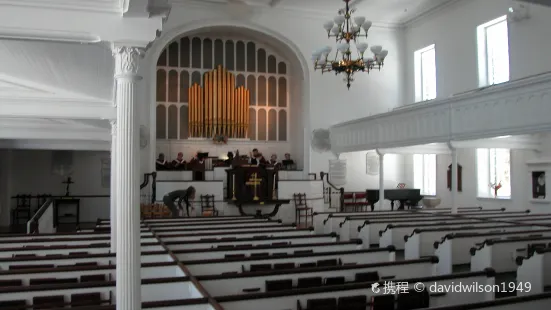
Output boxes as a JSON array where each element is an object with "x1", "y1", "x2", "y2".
[{"x1": 112, "y1": 45, "x2": 145, "y2": 80}]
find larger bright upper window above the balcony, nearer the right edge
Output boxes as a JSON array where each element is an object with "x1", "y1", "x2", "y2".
[{"x1": 477, "y1": 15, "x2": 509, "y2": 87}]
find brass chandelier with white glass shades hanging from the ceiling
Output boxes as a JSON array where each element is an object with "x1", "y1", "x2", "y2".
[{"x1": 312, "y1": 0, "x2": 388, "y2": 89}]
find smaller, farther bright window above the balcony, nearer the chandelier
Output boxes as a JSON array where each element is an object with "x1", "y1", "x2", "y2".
[{"x1": 414, "y1": 44, "x2": 436, "y2": 102}]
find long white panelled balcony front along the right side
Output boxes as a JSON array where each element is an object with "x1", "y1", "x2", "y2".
[{"x1": 330, "y1": 73, "x2": 551, "y2": 153}]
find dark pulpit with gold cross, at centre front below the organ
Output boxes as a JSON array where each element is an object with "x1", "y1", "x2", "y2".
[{"x1": 226, "y1": 164, "x2": 290, "y2": 218}]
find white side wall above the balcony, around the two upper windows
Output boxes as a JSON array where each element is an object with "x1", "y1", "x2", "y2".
[{"x1": 404, "y1": 0, "x2": 551, "y2": 104}]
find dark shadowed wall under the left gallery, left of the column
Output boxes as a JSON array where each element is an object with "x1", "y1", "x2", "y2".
[{"x1": 4, "y1": 150, "x2": 110, "y2": 225}]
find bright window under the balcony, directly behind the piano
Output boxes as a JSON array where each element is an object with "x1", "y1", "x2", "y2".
[{"x1": 413, "y1": 154, "x2": 436, "y2": 196}]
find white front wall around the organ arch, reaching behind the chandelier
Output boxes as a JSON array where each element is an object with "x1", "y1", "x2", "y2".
[{"x1": 138, "y1": 3, "x2": 403, "y2": 177}]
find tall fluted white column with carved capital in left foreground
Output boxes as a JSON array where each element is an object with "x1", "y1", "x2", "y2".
[{"x1": 113, "y1": 46, "x2": 142, "y2": 310}]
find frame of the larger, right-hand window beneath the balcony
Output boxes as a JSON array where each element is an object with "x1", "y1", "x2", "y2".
[{"x1": 475, "y1": 148, "x2": 513, "y2": 200}]
